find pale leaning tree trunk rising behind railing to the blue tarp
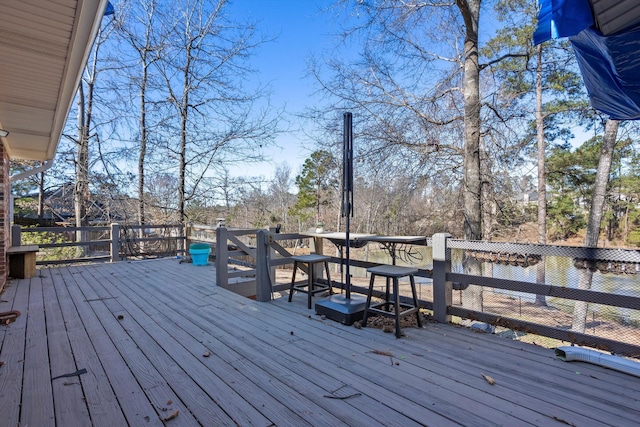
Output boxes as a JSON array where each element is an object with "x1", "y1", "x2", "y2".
[{"x1": 571, "y1": 119, "x2": 618, "y2": 333}]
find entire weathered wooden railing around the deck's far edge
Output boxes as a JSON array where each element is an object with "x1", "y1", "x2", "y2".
[{"x1": 12, "y1": 224, "x2": 640, "y2": 357}]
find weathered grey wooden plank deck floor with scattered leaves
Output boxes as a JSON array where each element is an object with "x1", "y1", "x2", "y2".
[{"x1": 0, "y1": 259, "x2": 640, "y2": 427}]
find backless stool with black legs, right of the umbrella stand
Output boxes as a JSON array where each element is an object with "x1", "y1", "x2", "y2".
[{"x1": 362, "y1": 265, "x2": 422, "y2": 338}]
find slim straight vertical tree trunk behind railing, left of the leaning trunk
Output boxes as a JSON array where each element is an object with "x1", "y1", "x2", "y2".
[{"x1": 536, "y1": 45, "x2": 547, "y2": 306}]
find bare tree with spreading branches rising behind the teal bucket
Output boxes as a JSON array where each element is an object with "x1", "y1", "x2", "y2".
[{"x1": 158, "y1": 0, "x2": 277, "y2": 221}]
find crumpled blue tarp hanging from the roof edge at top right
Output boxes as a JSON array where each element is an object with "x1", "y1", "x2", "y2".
[{"x1": 534, "y1": 0, "x2": 640, "y2": 120}]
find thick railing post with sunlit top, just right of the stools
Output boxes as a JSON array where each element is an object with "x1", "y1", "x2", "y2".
[{"x1": 432, "y1": 233, "x2": 453, "y2": 323}]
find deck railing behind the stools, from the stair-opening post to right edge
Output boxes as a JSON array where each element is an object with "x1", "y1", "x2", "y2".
[{"x1": 250, "y1": 230, "x2": 640, "y2": 357}]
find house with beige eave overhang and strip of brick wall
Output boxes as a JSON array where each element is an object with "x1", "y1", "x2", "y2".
[{"x1": 0, "y1": 0, "x2": 108, "y2": 289}]
